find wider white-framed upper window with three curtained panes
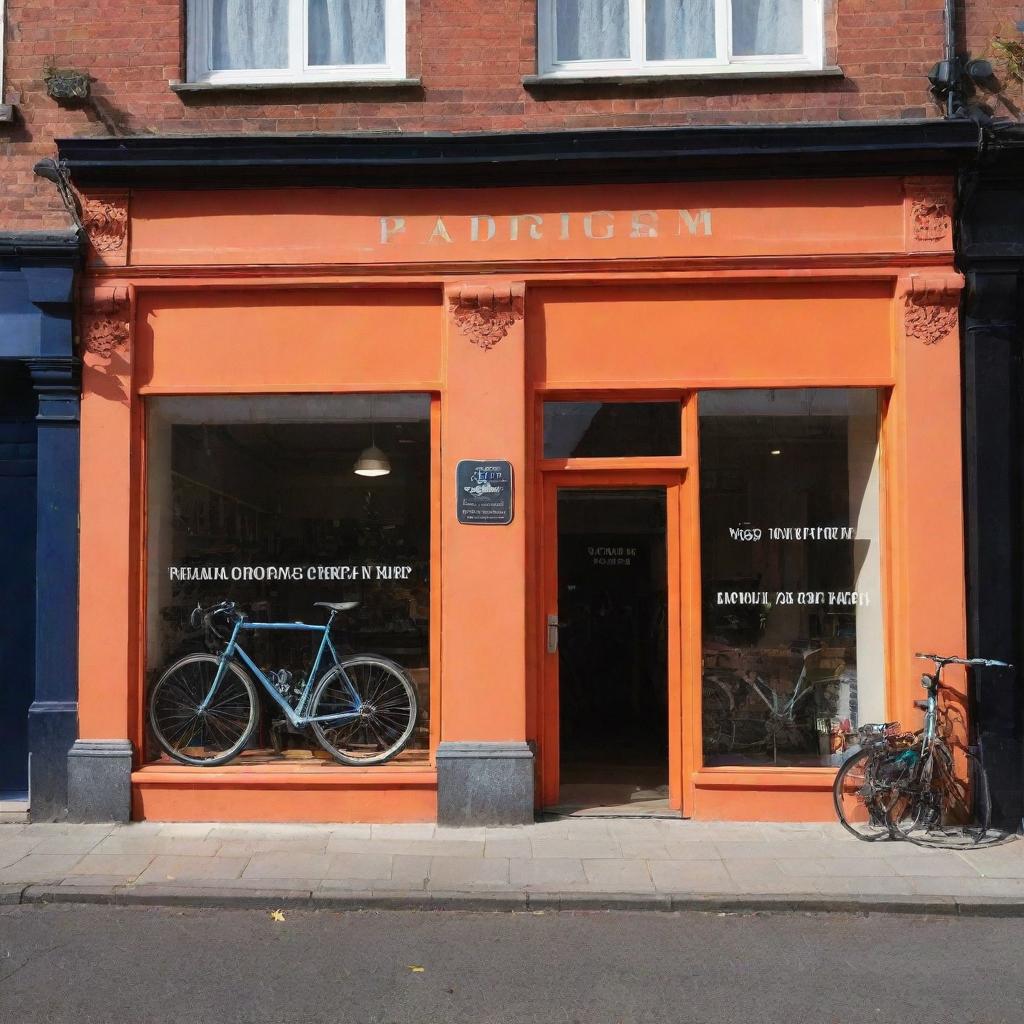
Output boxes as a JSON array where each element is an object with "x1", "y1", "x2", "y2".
[{"x1": 538, "y1": 0, "x2": 823, "y2": 78}]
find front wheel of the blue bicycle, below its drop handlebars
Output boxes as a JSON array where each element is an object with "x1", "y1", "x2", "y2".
[{"x1": 150, "y1": 654, "x2": 259, "y2": 768}]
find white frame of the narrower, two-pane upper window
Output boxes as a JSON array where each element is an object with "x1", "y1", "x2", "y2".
[{"x1": 186, "y1": 0, "x2": 406, "y2": 85}]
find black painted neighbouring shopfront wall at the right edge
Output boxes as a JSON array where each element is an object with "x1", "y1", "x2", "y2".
[{"x1": 957, "y1": 129, "x2": 1024, "y2": 828}]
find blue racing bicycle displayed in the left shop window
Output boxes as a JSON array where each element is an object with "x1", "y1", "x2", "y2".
[{"x1": 150, "y1": 601, "x2": 417, "y2": 768}]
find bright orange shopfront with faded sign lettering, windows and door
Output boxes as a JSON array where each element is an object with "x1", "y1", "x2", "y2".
[{"x1": 59, "y1": 140, "x2": 966, "y2": 824}]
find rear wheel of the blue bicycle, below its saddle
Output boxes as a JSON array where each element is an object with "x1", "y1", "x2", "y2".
[{"x1": 309, "y1": 654, "x2": 417, "y2": 765}]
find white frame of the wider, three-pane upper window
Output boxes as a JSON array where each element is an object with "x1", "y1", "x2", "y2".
[{"x1": 537, "y1": 0, "x2": 824, "y2": 79}]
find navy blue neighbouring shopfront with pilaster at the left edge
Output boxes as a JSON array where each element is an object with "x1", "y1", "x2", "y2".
[{"x1": 0, "y1": 232, "x2": 81, "y2": 821}]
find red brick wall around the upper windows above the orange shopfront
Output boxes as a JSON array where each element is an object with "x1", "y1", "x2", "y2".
[{"x1": 0, "y1": 0, "x2": 954, "y2": 230}]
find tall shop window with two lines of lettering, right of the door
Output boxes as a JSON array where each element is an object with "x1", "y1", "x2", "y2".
[{"x1": 698, "y1": 388, "x2": 885, "y2": 766}]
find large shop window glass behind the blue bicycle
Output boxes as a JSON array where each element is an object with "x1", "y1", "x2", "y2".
[{"x1": 146, "y1": 394, "x2": 431, "y2": 770}]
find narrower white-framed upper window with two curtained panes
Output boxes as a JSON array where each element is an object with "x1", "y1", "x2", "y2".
[{"x1": 188, "y1": 0, "x2": 406, "y2": 85}]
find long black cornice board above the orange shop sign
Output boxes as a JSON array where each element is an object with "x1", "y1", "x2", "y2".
[{"x1": 57, "y1": 119, "x2": 980, "y2": 188}]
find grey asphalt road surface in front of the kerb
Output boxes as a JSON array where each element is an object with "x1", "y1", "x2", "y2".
[{"x1": 0, "y1": 905, "x2": 1024, "y2": 1024}]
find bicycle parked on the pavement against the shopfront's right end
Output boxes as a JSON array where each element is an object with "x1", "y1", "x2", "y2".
[{"x1": 833, "y1": 654, "x2": 1013, "y2": 847}]
